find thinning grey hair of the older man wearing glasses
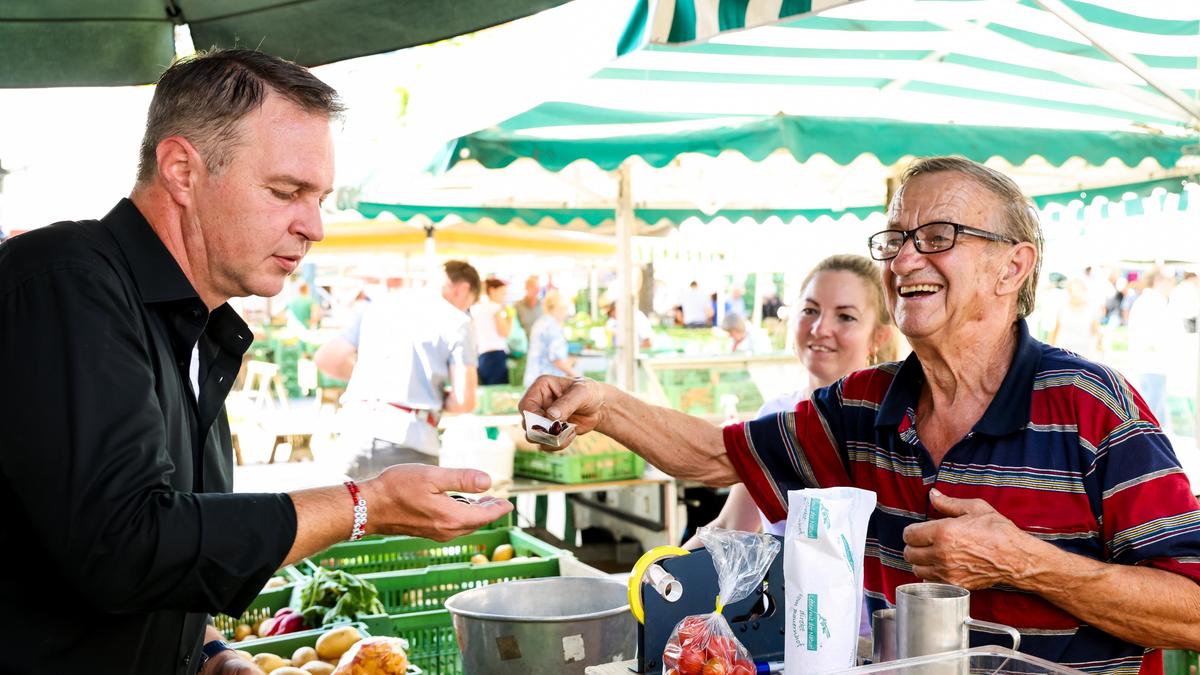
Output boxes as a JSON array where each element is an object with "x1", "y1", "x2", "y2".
[{"x1": 900, "y1": 155, "x2": 1043, "y2": 317}]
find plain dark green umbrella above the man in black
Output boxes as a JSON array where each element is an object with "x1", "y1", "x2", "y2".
[{"x1": 0, "y1": 0, "x2": 568, "y2": 88}]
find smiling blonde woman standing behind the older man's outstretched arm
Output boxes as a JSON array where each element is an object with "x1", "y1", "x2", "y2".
[{"x1": 684, "y1": 255, "x2": 896, "y2": 540}]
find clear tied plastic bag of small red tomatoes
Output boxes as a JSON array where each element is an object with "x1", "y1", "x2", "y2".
[{"x1": 662, "y1": 527, "x2": 779, "y2": 675}]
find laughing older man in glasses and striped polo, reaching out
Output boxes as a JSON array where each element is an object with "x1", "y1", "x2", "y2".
[{"x1": 521, "y1": 157, "x2": 1200, "y2": 673}]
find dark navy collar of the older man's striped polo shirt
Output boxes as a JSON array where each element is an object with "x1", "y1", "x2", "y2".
[{"x1": 875, "y1": 318, "x2": 1042, "y2": 436}]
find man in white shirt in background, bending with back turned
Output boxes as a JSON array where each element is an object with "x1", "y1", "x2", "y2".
[{"x1": 316, "y1": 261, "x2": 480, "y2": 478}]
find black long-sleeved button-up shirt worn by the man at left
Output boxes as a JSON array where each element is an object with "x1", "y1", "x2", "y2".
[{"x1": 0, "y1": 199, "x2": 296, "y2": 675}]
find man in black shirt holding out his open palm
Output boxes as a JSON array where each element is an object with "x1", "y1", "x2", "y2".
[{"x1": 0, "y1": 50, "x2": 511, "y2": 675}]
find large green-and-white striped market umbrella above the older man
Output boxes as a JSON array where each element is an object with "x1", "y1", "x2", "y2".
[{"x1": 364, "y1": 0, "x2": 1200, "y2": 384}]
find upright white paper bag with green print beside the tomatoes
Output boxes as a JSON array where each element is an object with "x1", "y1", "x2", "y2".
[{"x1": 784, "y1": 488, "x2": 875, "y2": 675}]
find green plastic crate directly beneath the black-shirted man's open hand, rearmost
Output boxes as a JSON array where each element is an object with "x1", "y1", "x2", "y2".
[{"x1": 295, "y1": 527, "x2": 564, "y2": 574}]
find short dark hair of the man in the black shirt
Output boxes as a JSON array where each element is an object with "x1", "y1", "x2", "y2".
[{"x1": 138, "y1": 49, "x2": 346, "y2": 185}]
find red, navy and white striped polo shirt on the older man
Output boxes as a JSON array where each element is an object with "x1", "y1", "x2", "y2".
[{"x1": 725, "y1": 319, "x2": 1200, "y2": 674}]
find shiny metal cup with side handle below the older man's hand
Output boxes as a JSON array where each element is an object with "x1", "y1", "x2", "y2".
[{"x1": 896, "y1": 584, "x2": 1021, "y2": 658}]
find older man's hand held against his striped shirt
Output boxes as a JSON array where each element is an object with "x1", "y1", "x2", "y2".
[{"x1": 904, "y1": 489, "x2": 1037, "y2": 590}]
